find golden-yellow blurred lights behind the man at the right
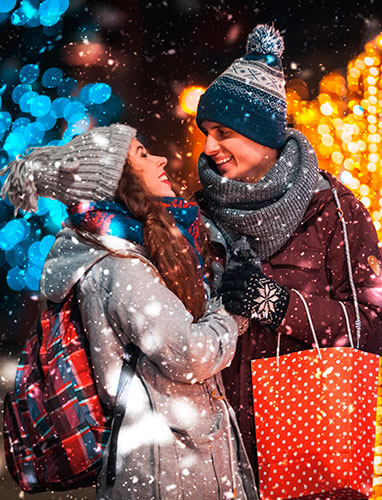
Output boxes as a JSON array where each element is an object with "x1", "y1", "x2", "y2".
[{"x1": 287, "y1": 33, "x2": 382, "y2": 240}]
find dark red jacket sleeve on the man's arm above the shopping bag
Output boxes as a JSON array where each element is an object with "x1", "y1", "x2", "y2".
[{"x1": 278, "y1": 196, "x2": 382, "y2": 353}]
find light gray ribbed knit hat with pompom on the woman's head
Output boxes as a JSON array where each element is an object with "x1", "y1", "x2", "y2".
[{"x1": 0, "y1": 123, "x2": 136, "y2": 211}]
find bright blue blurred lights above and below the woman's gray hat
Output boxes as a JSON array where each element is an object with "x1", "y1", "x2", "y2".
[{"x1": 0, "y1": 60, "x2": 122, "y2": 291}]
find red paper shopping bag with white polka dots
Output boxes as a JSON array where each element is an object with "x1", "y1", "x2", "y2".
[{"x1": 252, "y1": 347, "x2": 379, "y2": 500}]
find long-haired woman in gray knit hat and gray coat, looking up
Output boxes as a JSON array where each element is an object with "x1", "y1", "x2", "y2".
[{"x1": 2, "y1": 124, "x2": 257, "y2": 500}]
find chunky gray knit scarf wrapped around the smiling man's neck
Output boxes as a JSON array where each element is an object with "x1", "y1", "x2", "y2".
[{"x1": 199, "y1": 129, "x2": 319, "y2": 260}]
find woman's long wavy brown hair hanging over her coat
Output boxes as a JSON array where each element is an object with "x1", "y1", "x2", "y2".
[{"x1": 116, "y1": 161, "x2": 212, "y2": 321}]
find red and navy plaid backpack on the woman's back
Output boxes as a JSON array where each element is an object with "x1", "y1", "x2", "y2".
[{"x1": 4, "y1": 287, "x2": 136, "y2": 493}]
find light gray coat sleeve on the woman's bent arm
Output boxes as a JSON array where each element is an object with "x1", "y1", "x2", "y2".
[{"x1": 81, "y1": 257, "x2": 237, "y2": 383}]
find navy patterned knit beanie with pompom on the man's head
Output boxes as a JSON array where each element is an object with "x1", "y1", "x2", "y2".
[{"x1": 196, "y1": 25, "x2": 286, "y2": 149}]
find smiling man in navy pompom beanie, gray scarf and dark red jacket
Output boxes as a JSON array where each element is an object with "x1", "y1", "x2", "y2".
[{"x1": 196, "y1": 25, "x2": 382, "y2": 478}]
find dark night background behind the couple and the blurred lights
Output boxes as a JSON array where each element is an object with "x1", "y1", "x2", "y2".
[{"x1": 0, "y1": 0, "x2": 382, "y2": 500}]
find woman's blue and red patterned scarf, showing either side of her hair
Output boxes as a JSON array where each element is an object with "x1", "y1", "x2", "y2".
[{"x1": 65, "y1": 196, "x2": 204, "y2": 274}]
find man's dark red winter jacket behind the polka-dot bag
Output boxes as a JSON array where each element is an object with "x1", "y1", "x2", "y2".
[{"x1": 219, "y1": 172, "x2": 382, "y2": 471}]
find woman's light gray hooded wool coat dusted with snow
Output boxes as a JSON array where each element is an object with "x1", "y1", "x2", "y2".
[{"x1": 41, "y1": 228, "x2": 257, "y2": 500}]
